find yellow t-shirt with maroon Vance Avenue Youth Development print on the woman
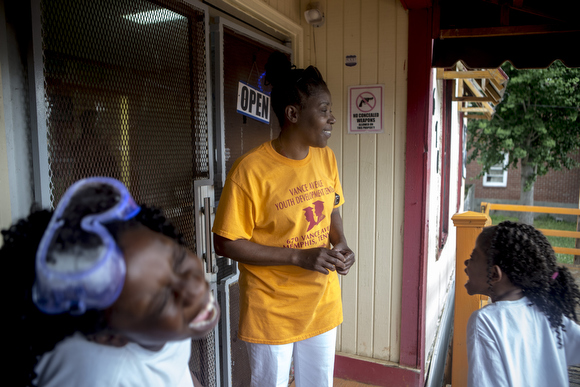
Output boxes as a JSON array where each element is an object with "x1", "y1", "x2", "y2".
[{"x1": 212, "y1": 142, "x2": 344, "y2": 344}]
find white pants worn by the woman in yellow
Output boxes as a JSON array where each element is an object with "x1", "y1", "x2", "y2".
[{"x1": 246, "y1": 328, "x2": 336, "y2": 387}]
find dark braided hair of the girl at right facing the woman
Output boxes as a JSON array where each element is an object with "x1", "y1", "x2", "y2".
[{"x1": 482, "y1": 220, "x2": 580, "y2": 345}]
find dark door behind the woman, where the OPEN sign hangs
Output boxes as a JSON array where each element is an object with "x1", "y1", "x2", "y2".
[{"x1": 212, "y1": 18, "x2": 291, "y2": 387}]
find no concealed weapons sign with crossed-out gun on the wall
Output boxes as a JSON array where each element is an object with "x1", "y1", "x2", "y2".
[{"x1": 348, "y1": 85, "x2": 385, "y2": 133}]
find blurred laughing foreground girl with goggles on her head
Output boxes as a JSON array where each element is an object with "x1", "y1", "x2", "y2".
[{"x1": 0, "y1": 177, "x2": 219, "y2": 386}]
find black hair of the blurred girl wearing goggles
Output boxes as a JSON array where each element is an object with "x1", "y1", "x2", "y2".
[{"x1": 0, "y1": 186, "x2": 185, "y2": 386}]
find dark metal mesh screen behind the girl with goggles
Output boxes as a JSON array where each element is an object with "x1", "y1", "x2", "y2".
[{"x1": 39, "y1": 0, "x2": 216, "y2": 387}]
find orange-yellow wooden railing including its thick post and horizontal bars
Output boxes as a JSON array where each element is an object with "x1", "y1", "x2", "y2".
[{"x1": 451, "y1": 203, "x2": 580, "y2": 387}]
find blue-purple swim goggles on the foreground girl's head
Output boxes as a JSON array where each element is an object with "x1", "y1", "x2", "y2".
[{"x1": 32, "y1": 177, "x2": 141, "y2": 314}]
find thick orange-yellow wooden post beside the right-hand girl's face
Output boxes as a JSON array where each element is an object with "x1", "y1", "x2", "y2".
[{"x1": 451, "y1": 211, "x2": 491, "y2": 387}]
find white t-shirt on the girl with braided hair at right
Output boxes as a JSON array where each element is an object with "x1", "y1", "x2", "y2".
[{"x1": 467, "y1": 297, "x2": 580, "y2": 387}]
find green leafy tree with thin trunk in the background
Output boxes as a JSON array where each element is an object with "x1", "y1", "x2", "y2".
[{"x1": 467, "y1": 61, "x2": 580, "y2": 224}]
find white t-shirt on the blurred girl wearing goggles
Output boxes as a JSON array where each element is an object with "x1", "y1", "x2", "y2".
[{"x1": 35, "y1": 333, "x2": 193, "y2": 387}]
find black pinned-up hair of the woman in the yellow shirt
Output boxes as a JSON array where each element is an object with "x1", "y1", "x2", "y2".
[{"x1": 265, "y1": 51, "x2": 328, "y2": 127}]
